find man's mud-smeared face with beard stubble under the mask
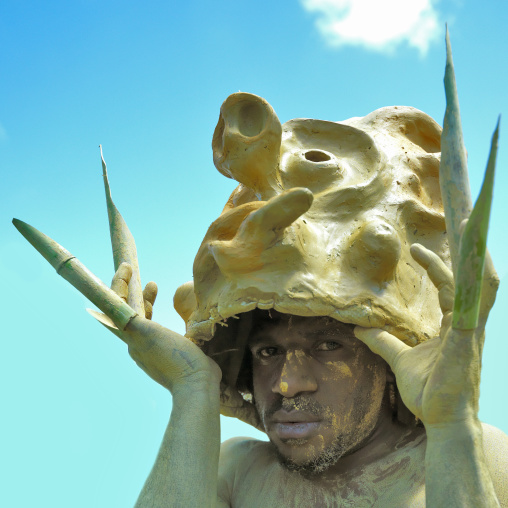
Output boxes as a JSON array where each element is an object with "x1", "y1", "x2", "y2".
[{"x1": 249, "y1": 313, "x2": 386, "y2": 473}]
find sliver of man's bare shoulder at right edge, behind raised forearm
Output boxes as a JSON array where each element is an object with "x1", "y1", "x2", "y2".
[{"x1": 482, "y1": 423, "x2": 508, "y2": 507}]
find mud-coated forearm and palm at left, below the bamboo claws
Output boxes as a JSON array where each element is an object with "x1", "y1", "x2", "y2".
[{"x1": 112, "y1": 278, "x2": 225, "y2": 508}]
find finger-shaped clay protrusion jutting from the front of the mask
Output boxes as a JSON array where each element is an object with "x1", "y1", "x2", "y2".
[{"x1": 209, "y1": 188, "x2": 313, "y2": 274}]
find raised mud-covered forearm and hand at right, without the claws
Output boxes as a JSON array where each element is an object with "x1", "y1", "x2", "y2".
[{"x1": 355, "y1": 238, "x2": 506, "y2": 508}]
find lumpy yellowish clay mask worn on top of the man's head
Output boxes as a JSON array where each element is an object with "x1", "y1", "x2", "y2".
[{"x1": 175, "y1": 93, "x2": 450, "y2": 345}]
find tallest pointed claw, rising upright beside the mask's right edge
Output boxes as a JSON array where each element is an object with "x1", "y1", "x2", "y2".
[{"x1": 439, "y1": 28, "x2": 473, "y2": 278}]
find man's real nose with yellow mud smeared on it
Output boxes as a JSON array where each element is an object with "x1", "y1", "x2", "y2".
[{"x1": 272, "y1": 349, "x2": 317, "y2": 397}]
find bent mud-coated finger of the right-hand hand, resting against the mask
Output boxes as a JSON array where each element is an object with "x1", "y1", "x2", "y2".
[{"x1": 410, "y1": 243, "x2": 455, "y2": 314}]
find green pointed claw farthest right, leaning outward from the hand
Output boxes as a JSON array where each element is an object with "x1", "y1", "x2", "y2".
[{"x1": 453, "y1": 120, "x2": 499, "y2": 330}]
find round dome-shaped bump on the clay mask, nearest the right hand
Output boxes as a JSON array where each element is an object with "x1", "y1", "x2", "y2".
[{"x1": 350, "y1": 219, "x2": 401, "y2": 283}]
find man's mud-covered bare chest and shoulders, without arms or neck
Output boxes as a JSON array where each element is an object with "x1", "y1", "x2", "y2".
[{"x1": 218, "y1": 424, "x2": 508, "y2": 508}]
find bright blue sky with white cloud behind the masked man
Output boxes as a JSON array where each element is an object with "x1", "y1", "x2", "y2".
[{"x1": 0, "y1": 0, "x2": 508, "y2": 508}]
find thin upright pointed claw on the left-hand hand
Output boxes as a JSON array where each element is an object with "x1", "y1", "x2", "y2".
[{"x1": 99, "y1": 145, "x2": 145, "y2": 316}]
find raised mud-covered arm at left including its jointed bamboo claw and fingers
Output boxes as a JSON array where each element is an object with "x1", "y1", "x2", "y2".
[{"x1": 13, "y1": 219, "x2": 227, "y2": 508}]
